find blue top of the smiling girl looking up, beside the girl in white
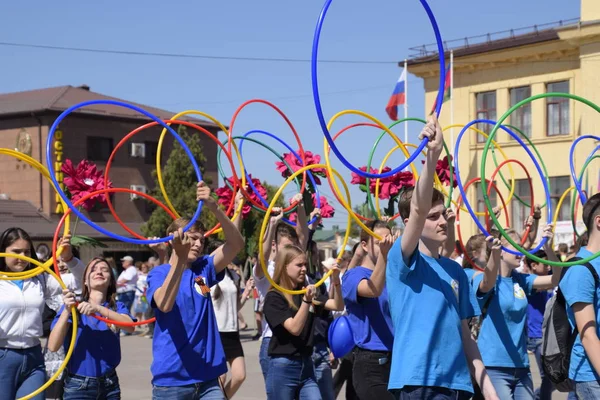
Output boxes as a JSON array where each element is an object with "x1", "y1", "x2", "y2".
[{"x1": 51, "y1": 301, "x2": 137, "y2": 377}]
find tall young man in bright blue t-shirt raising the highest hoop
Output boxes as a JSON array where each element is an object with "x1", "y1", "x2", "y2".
[{"x1": 386, "y1": 117, "x2": 498, "y2": 400}]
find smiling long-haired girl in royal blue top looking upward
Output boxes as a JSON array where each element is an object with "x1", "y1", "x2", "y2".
[{"x1": 48, "y1": 257, "x2": 135, "y2": 400}]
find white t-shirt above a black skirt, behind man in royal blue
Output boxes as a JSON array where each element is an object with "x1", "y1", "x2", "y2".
[{"x1": 210, "y1": 271, "x2": 240, "y2": 332}]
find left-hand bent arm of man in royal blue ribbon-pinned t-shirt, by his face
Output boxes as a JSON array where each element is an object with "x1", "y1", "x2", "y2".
[{"x1": 151, "y1": 229, "x2": 192, "y2": 313}]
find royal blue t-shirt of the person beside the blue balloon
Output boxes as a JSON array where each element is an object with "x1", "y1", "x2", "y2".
[{"x1": 342, "y1": 267, "x2": 394, "y2": 351}]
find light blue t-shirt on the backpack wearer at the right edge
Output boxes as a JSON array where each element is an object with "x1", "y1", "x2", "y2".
[{"x1": 559, "y1": 247, "x2": 600, "y2": 382}]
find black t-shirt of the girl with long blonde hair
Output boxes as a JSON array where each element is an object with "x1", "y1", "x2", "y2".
[{"x1": 263, "y1": 290, "x2": 328, "y2": 356}]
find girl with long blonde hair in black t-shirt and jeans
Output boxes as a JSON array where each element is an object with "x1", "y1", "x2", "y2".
[{"x1": 264, "y1": 245, "x2": 344, "y2": 400}]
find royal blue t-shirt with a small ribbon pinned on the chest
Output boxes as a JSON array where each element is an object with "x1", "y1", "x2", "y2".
[{"x1": 146, "y1": 256, "x2": 227, "y2": 386}]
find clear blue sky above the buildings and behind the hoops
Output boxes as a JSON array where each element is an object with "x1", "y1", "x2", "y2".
[{"x1": 0, "y1": 0, "x2": 580, "y2": 226}]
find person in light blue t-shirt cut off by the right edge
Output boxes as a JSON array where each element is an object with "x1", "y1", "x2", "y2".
[{"x1": 559, "y1": 193, "x2": 600, "y2": 400}]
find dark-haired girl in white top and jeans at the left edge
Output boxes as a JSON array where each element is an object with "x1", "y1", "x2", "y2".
[{"x1": 0, "y1": 228, "x2": 85, "y2": 400}]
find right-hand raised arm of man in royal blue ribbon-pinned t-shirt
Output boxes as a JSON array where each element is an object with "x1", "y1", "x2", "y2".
[{"x1": 196, "y1": 181, "x2": 244, "y2": 274}]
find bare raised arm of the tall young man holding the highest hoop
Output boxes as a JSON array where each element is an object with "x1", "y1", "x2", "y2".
[{"x1": 401, "y1": 116, "x2": 444, "y2": 262}]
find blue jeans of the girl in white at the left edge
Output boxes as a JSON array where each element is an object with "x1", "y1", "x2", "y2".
[{"x1": 0, "y1": 346, "x2": 46, "y2": 400}]
